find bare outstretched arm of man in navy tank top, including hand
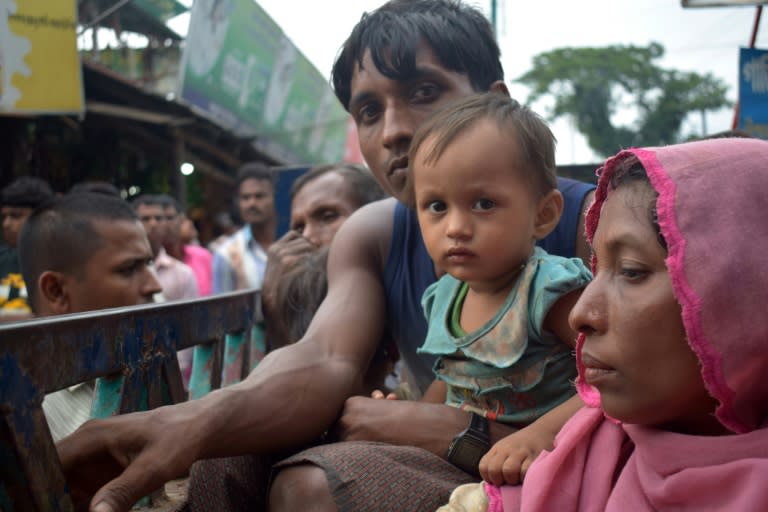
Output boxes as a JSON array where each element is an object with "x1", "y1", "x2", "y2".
[{"x1": 57, "y1": 201, "x2": 394, "y2": 511}]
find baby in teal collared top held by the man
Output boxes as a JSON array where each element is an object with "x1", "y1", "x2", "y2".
[{"x1": 409, "y1": 93, "x2": 591, "y2": 480}]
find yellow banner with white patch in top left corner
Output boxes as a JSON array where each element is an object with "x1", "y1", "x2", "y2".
[{"x1": 0, "y1": 0, "x2": 83, "y2": 114}]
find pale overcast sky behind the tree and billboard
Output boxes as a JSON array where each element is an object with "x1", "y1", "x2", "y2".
[{"x1": 174, "y1": 0, "x2": 768, "y2": 164}]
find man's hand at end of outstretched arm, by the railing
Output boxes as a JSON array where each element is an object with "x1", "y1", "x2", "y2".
[{"x1": 56, "y1": 409, "x2": 195, "y2": 512}]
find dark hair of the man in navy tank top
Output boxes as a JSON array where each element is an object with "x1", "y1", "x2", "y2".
[{"x1": 331, "y1": 0, "x2": 504, "y2": 110}]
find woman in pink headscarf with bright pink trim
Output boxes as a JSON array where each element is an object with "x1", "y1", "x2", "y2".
[{"x1": 444, "y1": 139, "x2": 768, "y2": 512}]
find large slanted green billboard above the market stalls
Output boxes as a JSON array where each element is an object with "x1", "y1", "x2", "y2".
[{"x1": 178, "y1": 0, "x2": 348, "y2": 164}]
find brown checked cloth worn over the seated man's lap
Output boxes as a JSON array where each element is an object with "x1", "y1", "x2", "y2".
[{"x1": 187, "y1": 442, "x2": 476, "y2": 512}]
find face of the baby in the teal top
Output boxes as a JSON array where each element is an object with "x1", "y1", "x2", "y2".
[{"x1": 412, "y1": 121, "x2": 539, "y2": 295}]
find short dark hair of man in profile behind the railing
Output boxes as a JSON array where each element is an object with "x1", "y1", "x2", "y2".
[{"x1": 18, "y1": 192, "x2": 139, "y2": 311}]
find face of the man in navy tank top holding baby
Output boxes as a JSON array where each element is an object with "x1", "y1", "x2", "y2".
[{"x1": 349, "y1": 43, "x2": 475, "y2": 201}]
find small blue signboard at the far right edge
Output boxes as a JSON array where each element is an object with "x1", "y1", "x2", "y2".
[{"x1": 738, "y1": 48, "x2": 768, "y2": 139}]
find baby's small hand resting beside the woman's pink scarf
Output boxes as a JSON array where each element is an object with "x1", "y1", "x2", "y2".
[{"x1": 479, "y1": 425, "x2": 555, "y2": 485}]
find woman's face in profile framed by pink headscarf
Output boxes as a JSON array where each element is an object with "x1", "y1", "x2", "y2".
[{"x1": 570, "y1": 182, "x2": 724, "y2": 435}]
